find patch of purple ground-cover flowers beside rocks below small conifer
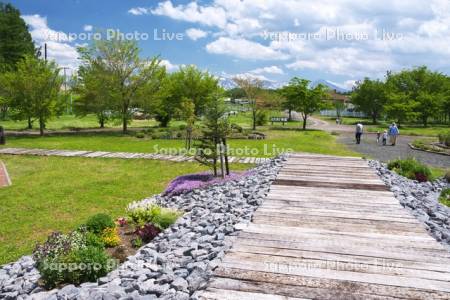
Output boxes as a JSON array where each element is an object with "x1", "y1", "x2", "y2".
[{"x1": 163, "y1": 171, "x2": 250, "y2": 196}]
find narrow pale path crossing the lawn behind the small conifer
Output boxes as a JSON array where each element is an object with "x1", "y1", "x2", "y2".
[{"x1": 0, "y1": 148, "x2": 269, "y2": 164}]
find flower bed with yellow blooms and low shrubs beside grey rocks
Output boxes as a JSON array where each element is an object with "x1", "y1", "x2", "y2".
[{"x1": 33, "y1": 204, "x2": 181, "y2": 289}]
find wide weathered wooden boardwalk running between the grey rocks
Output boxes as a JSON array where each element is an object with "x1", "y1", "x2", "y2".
[{"x1": 200, "y1": 154, "x2": 450, "y2": 300}]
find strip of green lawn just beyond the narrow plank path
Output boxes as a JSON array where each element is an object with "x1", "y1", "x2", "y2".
[{"x1": 0, "y1": 127, "x2": 358, "y2": 157}]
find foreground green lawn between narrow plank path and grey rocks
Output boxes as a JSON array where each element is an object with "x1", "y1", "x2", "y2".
[{"x1": 0, "y1": 155, "x2": 250, "y2": 265}]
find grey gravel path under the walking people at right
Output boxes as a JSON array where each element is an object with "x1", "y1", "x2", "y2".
[{"x1": 338, "y1": 133, "x2": 450, "y2": 168}]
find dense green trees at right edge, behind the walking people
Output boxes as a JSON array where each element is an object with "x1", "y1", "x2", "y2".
[{"x1": 351, "y1": 66, "x2": 450, "y2": 127}]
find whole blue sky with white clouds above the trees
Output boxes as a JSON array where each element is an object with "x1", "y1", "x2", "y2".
[{"x1": 7, "y1": 0, "x2": 450, "y2": 87}]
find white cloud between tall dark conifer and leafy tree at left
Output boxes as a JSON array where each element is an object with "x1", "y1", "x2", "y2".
[{"x1": 22, "y1": 15, "x2": 78, "y2": 69}]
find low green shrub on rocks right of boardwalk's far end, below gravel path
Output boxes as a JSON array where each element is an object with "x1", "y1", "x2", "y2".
[{"x1": 388, "y1": 158, "x2": 432, "y2": 182}]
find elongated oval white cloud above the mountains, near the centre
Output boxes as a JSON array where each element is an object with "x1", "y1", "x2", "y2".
[{"x1": 206, "y1": 37, "x2": 288, "y2": 60}]
